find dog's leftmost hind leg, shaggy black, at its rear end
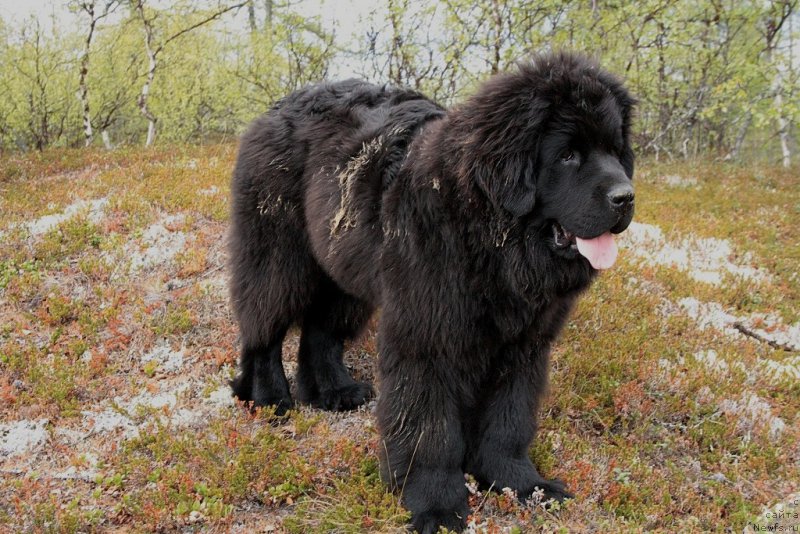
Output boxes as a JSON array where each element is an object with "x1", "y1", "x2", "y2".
[{"x1": 230, "y1": 165, "x2": 322, "y2": 415}]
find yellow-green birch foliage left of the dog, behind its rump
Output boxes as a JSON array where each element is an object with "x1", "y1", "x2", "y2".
[{"x1": 0, "y1": 1, "x2": 334, "y2": 152}]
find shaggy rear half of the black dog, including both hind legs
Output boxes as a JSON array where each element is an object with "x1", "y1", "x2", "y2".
[{"x1": 229, "y1": 80, "x2": 444, "y2": 413}]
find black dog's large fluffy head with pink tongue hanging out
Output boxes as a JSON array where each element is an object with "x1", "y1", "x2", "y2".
[{"x1": 459, "y1": 53, "x2": 635, "y2": 268}]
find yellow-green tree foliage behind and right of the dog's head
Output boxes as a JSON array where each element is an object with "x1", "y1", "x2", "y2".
[{"x1": 432, "y1": 0, "x2": 799, "y2": 161}]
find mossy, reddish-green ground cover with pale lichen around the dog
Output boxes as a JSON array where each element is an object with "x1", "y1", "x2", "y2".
[{"x1": 0, "y1": 145, "x2": 800, "y2": 533}]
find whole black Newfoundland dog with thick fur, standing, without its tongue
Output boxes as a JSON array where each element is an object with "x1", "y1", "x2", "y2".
[{"x1": 230, "y1": 54, "x2": 634, "y2": 533}]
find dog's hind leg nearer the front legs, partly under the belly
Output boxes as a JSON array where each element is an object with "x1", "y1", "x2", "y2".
[{"x1": 297, "y1": 280, "x2": 373, "y2": 411}]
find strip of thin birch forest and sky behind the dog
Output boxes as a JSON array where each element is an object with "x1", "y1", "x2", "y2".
[{"x1": 0, "y1": 0, "x2": 800, "y2": 166}]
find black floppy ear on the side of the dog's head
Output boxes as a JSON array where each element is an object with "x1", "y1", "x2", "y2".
[{"x1": 475, "y1": 154, "x2": 536, "y2": 217}]
